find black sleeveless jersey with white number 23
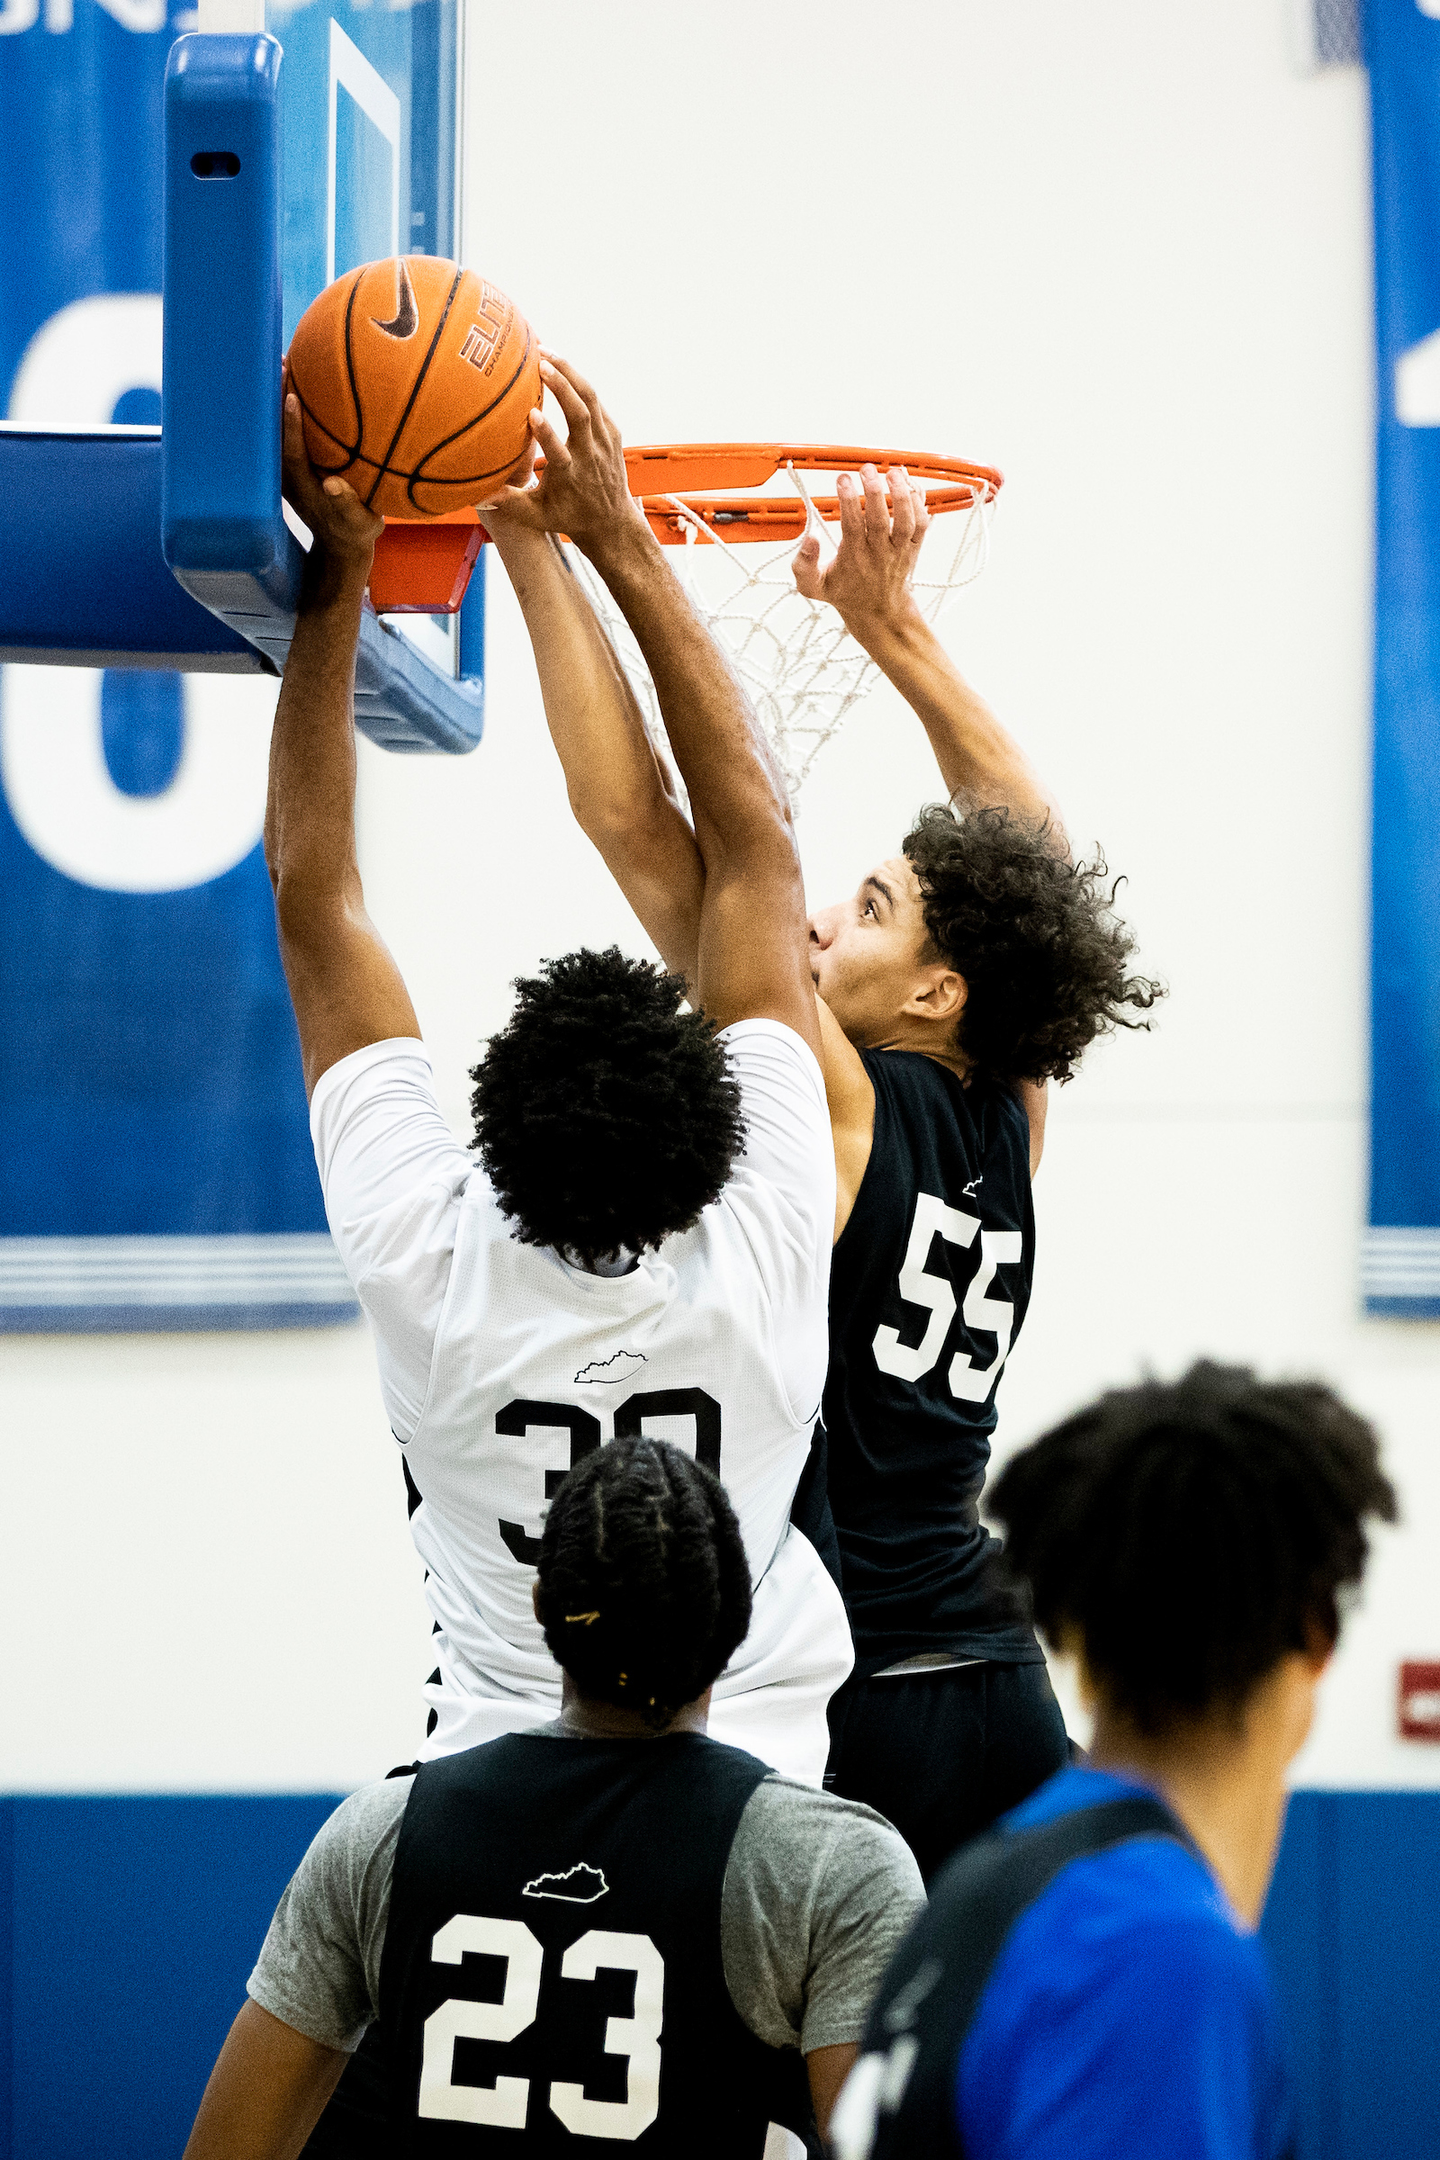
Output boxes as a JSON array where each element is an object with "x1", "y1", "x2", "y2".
[{"x1": 380, "y1": 1734, "x2": 799, "y2": 2160}]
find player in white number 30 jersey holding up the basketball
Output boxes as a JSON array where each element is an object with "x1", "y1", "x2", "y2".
[{"x1": 266, "y1": 363, "x2": 853, "y2": 1782}]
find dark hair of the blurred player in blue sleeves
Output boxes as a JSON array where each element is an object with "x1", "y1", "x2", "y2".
[{"x1": 989, "y1": 1361, "x2": 1397, "y2": 1734}]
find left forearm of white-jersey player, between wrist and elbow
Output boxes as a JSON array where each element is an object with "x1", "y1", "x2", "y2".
[{"x1": 266, "y1": 548, "x2": 365, "y2": 924}]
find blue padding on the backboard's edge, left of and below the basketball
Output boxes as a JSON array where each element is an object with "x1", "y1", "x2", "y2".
[{"x1": 160, "y1": 32, "x2": 484, "y2": 754}]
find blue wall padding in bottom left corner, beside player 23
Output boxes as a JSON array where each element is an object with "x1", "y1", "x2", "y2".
[{"x1": 0, "y1": 1793, "x2": 337, "y2": 2160}]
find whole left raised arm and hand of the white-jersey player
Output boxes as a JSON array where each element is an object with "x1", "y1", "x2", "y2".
[{"x1": 266, "y1": 395, "x2": 419, "y2": 1095}]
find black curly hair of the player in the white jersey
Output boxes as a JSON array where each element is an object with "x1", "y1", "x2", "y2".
[{"x1": 471, "y1": 946, "x2": 745, "y2": 1266}]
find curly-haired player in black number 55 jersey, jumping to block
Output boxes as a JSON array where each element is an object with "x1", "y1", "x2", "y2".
[{"x1": 484, "y1": 455, "x2": 1159, "y2": 1875}]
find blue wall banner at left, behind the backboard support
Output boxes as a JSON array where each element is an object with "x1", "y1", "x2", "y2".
[{"x1": 0, "y1": 0, "x2": 356, "y2": 1331}]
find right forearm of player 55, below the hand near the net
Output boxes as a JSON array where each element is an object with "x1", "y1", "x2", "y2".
[{"x1": 846, "y1": 609, "x2": 1062, "y2": 832}]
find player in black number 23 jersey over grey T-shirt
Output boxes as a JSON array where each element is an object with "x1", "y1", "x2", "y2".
[{"x1": 186, "y1": 1441, "x2": 924, "y2": 2160}]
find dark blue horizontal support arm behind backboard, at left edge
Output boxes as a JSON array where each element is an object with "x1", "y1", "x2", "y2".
[{"x1": 0, "y1": 430, "x2": 261, "y2": 667}]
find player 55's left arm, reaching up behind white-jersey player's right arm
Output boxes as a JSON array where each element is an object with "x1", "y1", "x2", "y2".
[{"x1": 481, "y1": 503, "x2": 706, "y2": 981}]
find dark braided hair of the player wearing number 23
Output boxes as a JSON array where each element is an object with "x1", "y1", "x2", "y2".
[{"x1": 535, "y1": 1436, "x2": 749, "y2": 1732}]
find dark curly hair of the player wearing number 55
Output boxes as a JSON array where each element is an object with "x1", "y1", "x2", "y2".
[{"x1": 902, "y1": 804, "x2": 1164, "y2": 1082}]
